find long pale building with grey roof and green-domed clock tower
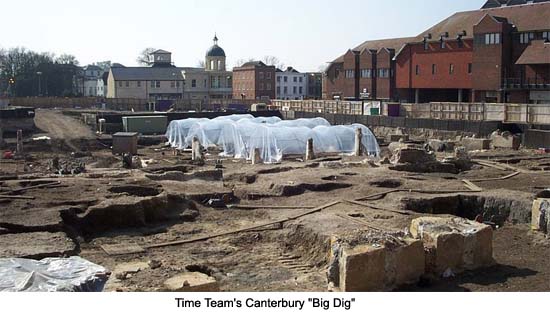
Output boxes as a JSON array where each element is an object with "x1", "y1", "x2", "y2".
[{"x1": 107, "y1": 35, "x2": 233, "y2": 105}]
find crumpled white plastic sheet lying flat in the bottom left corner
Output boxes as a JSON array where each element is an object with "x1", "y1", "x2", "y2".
[{"x1": 0, "y1": 256, "x2": 108, "y2": 292}]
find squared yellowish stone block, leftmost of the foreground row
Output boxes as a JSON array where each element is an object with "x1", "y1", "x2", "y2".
[{"x1": 340, "y1": 245, "x2": 386, "y2": 292}]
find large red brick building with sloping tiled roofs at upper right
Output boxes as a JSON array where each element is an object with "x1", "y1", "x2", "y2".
[{"x1": 324, "y1": 1, "x2": 550, "y2": 103}]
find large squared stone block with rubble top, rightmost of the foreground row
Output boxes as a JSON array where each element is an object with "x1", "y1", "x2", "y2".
[{"x1": 410, "y1": 217, "x2": 493, "y2": 275}]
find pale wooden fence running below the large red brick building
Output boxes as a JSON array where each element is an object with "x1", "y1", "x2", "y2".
[{"x1": 273, "y1": 100, "x2": 550, "y2": 124}]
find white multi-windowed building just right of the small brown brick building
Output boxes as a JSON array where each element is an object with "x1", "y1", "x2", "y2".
[{"x1": 275, "y1": 67, "x2": 307, "y2": 100}]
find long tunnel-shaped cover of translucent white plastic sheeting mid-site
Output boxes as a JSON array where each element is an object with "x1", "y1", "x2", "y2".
[{"x1": 167, "y1": 117, "x2": 380, "y2": 163}]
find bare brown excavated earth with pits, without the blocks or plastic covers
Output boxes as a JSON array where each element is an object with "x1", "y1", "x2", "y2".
[{"x1": 0, "y1": 111, "x2": 550, "y2": 291}]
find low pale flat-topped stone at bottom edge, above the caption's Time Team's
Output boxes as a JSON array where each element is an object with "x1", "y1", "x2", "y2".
[{"x1": 164, "y1": 272, "x2": 220, "y2": 292}]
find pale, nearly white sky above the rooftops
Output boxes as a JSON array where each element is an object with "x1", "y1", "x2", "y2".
[{"x1": 0, "y1": 0, "x2": 485, "y2": 71}]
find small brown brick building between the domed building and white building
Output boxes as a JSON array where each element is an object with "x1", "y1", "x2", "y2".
[{"x1": 233, "y1": 62, "x2": 276, "y2": 100}]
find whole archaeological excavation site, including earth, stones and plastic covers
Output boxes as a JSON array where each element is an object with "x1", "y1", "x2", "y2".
[{"x1": 0, "y1": 107, "x2": 550, "y2": 292}]
